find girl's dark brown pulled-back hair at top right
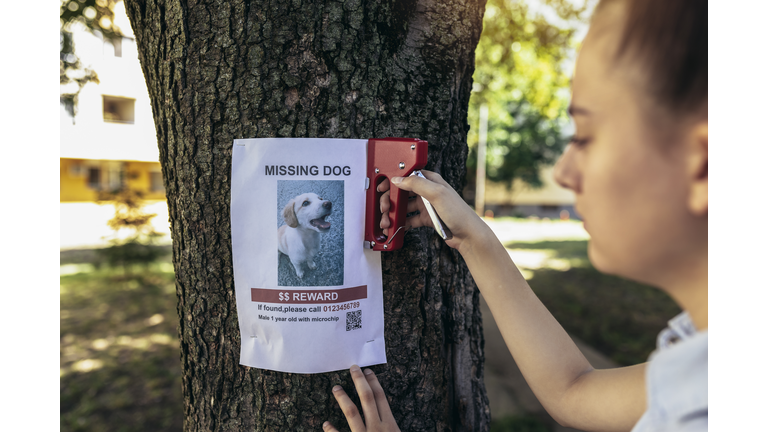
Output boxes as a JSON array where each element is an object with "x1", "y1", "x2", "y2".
[{"x1": 595, "y1": 0, "x2": 709, "y2": 114}]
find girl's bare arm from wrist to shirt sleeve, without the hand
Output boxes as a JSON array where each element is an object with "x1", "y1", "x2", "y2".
[{"x1": 459, "y1": 228, "x2": 645, "y2": 430}]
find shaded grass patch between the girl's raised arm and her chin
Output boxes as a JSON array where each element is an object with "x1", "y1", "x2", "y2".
[{"x1": 506, "y1": 240, "x2": 680, "y2": 365}]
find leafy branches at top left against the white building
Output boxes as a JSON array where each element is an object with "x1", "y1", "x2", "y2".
[{"x1": 59, "y1": 0, "x2": 122, "y2": 118}]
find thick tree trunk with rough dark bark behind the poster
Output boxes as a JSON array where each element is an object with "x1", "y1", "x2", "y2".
[{"x1": 126, "y1": 0, "x2": 489, "y2": 431}]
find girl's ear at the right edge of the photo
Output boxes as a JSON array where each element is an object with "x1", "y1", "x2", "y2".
[{"x1": 687, "y1": 120, "x2": 709, "y2": 216}]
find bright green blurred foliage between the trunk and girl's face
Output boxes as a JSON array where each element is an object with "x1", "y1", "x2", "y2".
[{"x1": 467, "y1": 0, "x2": 587, "y2": 187}]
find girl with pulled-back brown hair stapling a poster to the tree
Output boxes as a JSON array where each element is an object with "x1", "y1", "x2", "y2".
[{"x1": 324, "y1": 0, "x2": 708, "y2": 432}]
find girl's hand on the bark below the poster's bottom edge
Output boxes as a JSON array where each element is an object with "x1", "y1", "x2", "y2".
[{"x1": 323, "y1": 365, "x2": 400, "y2": 432}]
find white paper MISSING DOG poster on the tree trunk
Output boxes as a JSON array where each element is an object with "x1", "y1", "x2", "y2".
[{"x1": 226, "y1": 138, "x2": 387, "y2": 373}]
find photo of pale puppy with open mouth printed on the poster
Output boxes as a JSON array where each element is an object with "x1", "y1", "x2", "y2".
[{"x1": 276, "y1": 180, "x2": 344, "y2": 287}]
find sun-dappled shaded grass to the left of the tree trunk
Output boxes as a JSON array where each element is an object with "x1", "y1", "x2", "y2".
[{"x1": 60, "y1": 265, "x2": 183, "y2": 431}]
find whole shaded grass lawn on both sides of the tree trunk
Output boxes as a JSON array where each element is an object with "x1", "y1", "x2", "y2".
[{"x1": 60, "y1": 230, "x2": 679, "y2": 432}]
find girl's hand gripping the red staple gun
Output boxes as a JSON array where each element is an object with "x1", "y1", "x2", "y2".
[{"x1": 377, "y1": 170, "x2": 488, "y2": 252}]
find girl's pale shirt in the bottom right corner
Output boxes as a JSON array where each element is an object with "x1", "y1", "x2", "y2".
[{"x1": 632, "y1": 312, "x2": 708, "y2": 432}]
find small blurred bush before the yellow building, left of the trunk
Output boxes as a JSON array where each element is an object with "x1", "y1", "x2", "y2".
[{"x1": 99, "y1": 188, "x2": 165, "y2": 271}]
